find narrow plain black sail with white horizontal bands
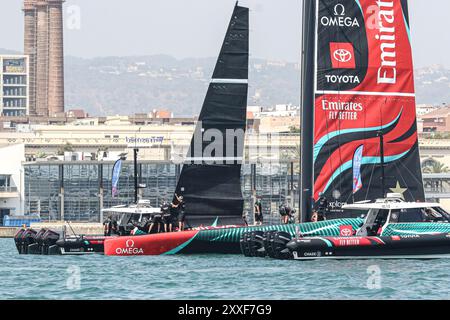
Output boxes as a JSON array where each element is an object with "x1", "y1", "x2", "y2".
[{"x1": 176, "y1": 3, "x2": 249, "y2": 226}]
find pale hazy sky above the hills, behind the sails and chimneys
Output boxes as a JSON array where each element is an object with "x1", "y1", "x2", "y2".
[{"x1": 0, "y1": 0, "x2": 450, "y2": 67}]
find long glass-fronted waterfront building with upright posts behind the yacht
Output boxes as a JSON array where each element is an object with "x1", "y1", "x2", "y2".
[{"x1": 23, "y1": 160, "x2": 298, "y2": 222}]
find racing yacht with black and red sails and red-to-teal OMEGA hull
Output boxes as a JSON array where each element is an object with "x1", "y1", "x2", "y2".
[{"x1": 14, "y1": 0, "x2": 442, "y2": 255}]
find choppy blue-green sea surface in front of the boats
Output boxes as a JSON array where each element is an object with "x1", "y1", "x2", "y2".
[{"x1": 0, "y1": 239, "x2": 450, "y2": 300}]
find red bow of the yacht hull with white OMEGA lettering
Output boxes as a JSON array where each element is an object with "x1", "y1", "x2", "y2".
[{"x1": 105, "y1": 231, "x2": 198, "y2": 256}]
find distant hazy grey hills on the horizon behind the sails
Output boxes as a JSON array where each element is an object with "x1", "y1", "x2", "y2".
[{"x1": 0, "y1": 49, "x2": 450, "y2": 116}]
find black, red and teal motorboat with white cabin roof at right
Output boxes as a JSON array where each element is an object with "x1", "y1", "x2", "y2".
[{"x1": 241, "y1": 195, "x2": 450, "y2": 260}]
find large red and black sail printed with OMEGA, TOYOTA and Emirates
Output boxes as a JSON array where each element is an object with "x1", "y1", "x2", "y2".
[{"x1": 314, "y1": 0, "x2": 424, "y2": 213}]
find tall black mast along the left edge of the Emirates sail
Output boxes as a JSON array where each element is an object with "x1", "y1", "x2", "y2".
[{"x1": 299, "y1": 0, "x2": 316, "y2": 222}]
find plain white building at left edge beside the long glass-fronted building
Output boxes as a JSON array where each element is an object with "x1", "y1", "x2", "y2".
[{"x1": 0, "y1": 144, "x2": 25, "y2": 225}]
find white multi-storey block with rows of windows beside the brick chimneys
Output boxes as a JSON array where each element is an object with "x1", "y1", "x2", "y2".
[{"x1": 0, "y1": 55, "x2": 29, "y2": 117}]
